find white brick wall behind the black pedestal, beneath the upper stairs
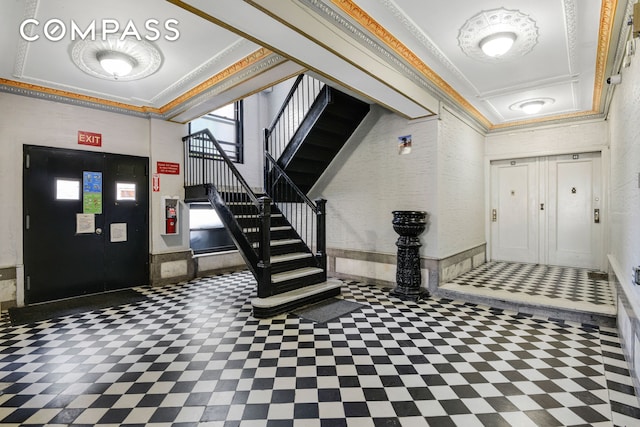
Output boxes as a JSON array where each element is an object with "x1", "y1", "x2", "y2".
[{"x1": 311, "y1": 106, "x2": 438, "y2": 256}]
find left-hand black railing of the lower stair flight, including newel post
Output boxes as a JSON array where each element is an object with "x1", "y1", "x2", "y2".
[{"x1": 182, "y1": 129, "x2": 271, "y2": 298}]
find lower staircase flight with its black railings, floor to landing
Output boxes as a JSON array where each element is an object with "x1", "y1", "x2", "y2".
[{"x1": 183, "y1": 130, "x2": 341, "y2": 318}]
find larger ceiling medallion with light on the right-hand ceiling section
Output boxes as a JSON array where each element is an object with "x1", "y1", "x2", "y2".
[{"x1": 458, "y1": 8, "x2": 538, "y2": 62}]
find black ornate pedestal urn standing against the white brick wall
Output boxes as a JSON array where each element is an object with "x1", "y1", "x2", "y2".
[{"x1": 391, "y1": 211, "x2": 429, "y2": 301}]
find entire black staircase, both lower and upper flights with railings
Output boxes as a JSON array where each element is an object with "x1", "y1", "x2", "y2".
[{"x1": 183, "y1": 75, "x2": 369, "y2": 318}]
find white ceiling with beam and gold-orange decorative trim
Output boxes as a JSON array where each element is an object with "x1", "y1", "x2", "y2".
[{"x1": 0, "y1": 0, "x2": 632, "y2": 131}]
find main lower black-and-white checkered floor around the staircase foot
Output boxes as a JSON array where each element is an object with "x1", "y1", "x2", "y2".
[{"x1": 0, "y1": 272, "x2": 640, "y2": 427}]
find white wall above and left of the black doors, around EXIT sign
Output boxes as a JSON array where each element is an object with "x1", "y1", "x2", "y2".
[{"x1": 0, "y1": 93, "x2": 156, "y2": 267}]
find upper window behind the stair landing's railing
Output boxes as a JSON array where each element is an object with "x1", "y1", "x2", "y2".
[{"x1": 189, "y1": 101, "x2": 244, "y2": 163}]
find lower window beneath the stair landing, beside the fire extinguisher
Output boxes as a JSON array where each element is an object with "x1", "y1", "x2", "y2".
[{"x1": 189, "y1": 203, "x2": 236, "y2": 254}]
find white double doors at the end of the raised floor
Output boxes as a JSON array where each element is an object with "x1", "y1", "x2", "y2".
[{"x1": 490, "y1": 153, "x2": 603, "y2": 269}]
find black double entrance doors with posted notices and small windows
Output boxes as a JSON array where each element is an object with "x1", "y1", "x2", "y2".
[{"x1": 23, "y1": 146, "x2": 149, "y2": 304}]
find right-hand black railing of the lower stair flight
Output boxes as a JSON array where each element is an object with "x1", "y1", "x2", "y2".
[{"x1": 265, "y1": 152, "x2": 327, "y2": 279}]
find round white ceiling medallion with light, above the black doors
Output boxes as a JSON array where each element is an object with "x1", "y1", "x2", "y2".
[{"x1": 71, "y1": 34, "x2": 162, "y2": 82}]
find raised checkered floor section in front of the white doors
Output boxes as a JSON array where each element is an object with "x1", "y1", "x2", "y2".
[{"x1": 442, "y1": 261, "x2": 616, "y2": 315}]
